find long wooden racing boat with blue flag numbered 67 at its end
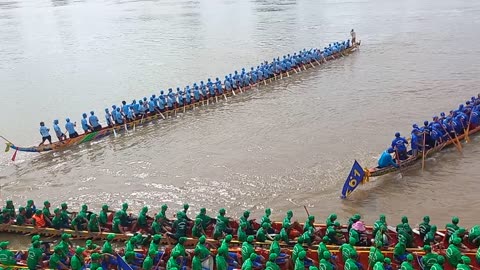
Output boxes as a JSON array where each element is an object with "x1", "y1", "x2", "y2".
[{"x1": 341, "y1": 121, "x2": 480, "y2": 198}]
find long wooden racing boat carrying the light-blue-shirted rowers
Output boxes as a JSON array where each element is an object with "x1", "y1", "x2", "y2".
[{"x1": 2, "y1": 42, "x2": 360, "y2": 159}]
